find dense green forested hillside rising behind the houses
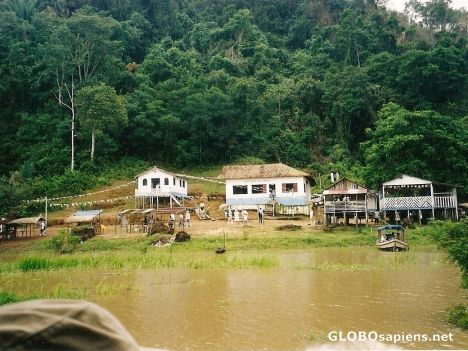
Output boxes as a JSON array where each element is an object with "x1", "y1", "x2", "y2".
[{"x1": 0, "y1": 0, "x2": 468, "y2": 213}]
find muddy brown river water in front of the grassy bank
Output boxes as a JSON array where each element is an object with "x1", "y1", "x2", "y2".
[{"x1": 0, "y1": 248, "x2": 468, "y2": 351}]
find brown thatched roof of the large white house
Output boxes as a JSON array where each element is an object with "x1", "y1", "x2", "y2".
[{"x1": 218, "y1": 163, "x2": 309, "y2": 179}]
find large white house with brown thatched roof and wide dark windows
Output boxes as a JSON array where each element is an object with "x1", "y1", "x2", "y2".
[{"x1": 218, "y1": 163, "x2": 310, "y2": 214}]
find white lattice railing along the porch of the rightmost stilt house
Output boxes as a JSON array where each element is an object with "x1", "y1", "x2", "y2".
[{"x1": 380, "y1": 195, "x2": 457, "y2": 211}]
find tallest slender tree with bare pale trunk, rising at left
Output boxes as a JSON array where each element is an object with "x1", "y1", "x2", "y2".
[{"x1": 43, "y1": 7, "x2": 123, "y2": 171}]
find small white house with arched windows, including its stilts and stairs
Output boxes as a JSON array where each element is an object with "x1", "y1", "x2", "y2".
[{"x1": 135, "y1": 167, "x2": 188, "y2": 209}]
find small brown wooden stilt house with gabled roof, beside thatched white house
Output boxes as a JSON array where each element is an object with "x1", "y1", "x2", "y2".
[{"x1": 322, "y1": 178, "x2": 377, "y2": 224}]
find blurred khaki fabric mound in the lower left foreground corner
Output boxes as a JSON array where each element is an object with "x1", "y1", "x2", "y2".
[{"x1": 0, "y1": 300, "x2": 141, "y2": 351}]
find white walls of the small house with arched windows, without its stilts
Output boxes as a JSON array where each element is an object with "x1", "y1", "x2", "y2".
[{"x1": 135, "y1": 170, "x2": 188, "y2": 196}]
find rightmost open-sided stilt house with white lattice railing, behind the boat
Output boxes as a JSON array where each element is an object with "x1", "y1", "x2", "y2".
[{"x1": 379, "y1": 174, "x2": 458, "y2": 223}]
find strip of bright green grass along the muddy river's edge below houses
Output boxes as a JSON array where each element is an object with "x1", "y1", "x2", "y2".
[{"x1": 0, "y1": 229, "x2": 436, "y2": 273}]
